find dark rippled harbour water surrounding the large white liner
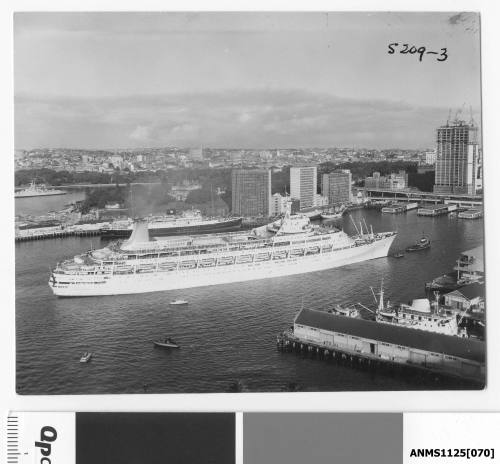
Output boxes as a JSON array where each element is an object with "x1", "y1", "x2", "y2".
[{"x1": 16, "y1": 210, "x2": 483, "y2": 394}]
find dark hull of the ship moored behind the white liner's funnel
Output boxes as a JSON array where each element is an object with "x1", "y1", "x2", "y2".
[{"x1": 101, "y1": 218, "x2": 242, "y2": 239}]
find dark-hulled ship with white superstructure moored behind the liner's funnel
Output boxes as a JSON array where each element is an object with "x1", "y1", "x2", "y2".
[{"x1": 101, "y1": 211, "x2": 243, "y2": 239}]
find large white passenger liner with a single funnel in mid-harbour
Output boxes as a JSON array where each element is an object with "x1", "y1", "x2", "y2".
[{"x1": 49, "y1": 208, "x2": 396, "y2": 296}]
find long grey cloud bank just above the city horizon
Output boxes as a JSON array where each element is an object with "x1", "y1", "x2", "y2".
[{"x1": 15, "y1": 89, "x2": 479, "y2": 148}]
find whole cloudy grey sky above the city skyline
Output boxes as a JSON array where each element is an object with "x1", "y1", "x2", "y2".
[{"x1": 14, "y1": 13, "x2": 480, "y2": 148}]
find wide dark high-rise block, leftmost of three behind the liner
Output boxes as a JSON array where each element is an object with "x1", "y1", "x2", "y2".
[{"x1": 231, "y1": 169, "x2": 271, "y2": 217}]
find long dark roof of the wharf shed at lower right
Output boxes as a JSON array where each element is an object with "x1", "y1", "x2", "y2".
[{"x1": 295, "y1": 309, "x2": 486, "y2": 363}]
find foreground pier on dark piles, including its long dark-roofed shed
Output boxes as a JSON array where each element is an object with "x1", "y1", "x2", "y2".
[{"x1": 276, "y1": 309, "x2": 485, "y2": 387}]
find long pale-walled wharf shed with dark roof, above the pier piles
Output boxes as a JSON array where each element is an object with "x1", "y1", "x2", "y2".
[{"x1": 293, "y1": 309, "x2": 486, "y2": 381}]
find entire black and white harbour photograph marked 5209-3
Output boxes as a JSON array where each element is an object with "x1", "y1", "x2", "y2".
[{"x1": 14, "y1": 11, "x2": 484, "y2": 395}]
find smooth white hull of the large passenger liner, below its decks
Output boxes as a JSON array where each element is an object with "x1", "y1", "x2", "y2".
[{"x1": 49, "y1": 235, "x2": 396, "y2": 297}]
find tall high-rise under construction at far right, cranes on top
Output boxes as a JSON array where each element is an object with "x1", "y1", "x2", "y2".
[{"x1": 434, "y1": 119, "x2": 482, "y2": 195}]
